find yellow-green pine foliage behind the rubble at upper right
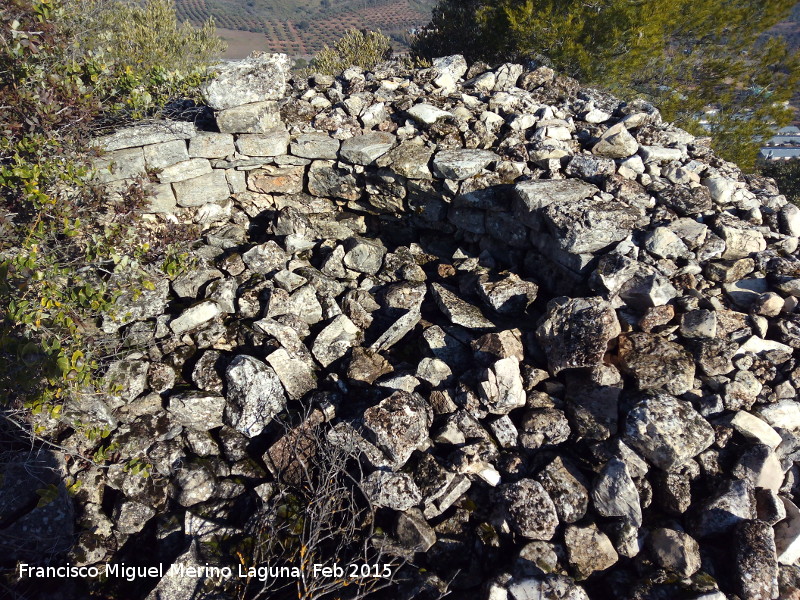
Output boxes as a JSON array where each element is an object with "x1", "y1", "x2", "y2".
[{"x1": 414, "y1": 0, "x2": 800, "y2": 168}]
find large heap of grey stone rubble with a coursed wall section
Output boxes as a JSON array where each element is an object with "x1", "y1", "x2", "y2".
[{"x1": 9, "y1": 55, "x2": 800, "y2": 600}]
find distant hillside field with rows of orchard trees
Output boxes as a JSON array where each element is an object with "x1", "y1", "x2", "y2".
[{"x1": 175, "y1": 0, "x2": 434, "y2": 58}]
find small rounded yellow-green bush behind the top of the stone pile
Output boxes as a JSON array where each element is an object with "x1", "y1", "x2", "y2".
[{"x1": 310, "y1": 29, "x2": 392, "y2": 75}]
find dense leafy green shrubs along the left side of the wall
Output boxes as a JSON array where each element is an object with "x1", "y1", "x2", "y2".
[{"x1": 0, "y1": 0, "x2": 222, "y2": 442}]
